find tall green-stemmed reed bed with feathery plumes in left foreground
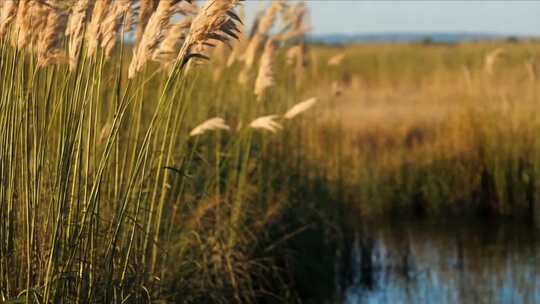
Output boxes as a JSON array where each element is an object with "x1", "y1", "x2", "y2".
[{"x1": 0, "y1": 0, "x2": 332, "y2": 303}]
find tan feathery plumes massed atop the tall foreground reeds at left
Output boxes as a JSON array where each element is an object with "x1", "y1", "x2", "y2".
[{"x1": 0, "y1": 0, "x2": 241, "y2": 74}]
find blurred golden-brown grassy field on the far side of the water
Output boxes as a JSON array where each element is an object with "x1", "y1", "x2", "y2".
[{"x1": 304, "y1": 42, "x2": 540, "y2": 219}]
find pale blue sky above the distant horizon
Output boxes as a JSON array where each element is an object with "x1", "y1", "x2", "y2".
[{"x1": 246, "y1": 0, "x2": 540, "y2": 36}]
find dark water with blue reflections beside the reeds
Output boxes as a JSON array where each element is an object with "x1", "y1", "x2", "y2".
[{"x1": 344, "y1": 221, "x2": 540, "y2": 304}]
